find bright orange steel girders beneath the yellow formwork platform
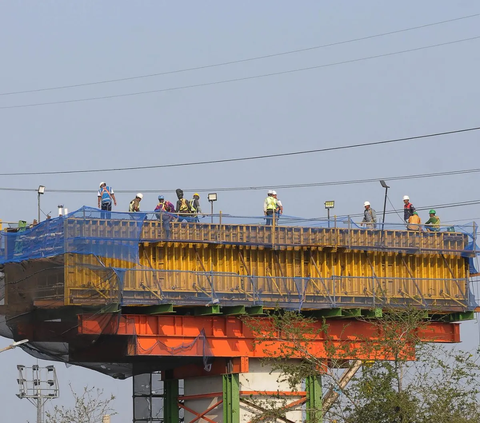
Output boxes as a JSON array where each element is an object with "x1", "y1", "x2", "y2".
[{"x1": 78, "y1": 314, "x2": 460, "y2": 359}]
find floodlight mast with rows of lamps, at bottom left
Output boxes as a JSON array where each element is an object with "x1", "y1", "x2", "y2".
[{"x1": 17, "y1": 364, "x2": 60, "y2": 423}]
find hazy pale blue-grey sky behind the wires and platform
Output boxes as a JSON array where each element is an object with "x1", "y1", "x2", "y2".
[{"x1": 0, "y1": 0, "x2": 480, "y2": 423}]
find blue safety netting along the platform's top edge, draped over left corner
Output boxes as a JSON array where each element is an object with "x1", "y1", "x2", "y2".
[{"x1": 0, "y1": 207, "x2": 479, "y2": 265}]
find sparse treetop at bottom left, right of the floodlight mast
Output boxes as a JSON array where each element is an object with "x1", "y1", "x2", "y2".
[{"x1": 45, "y1": 385, "x2": 117, "y2": 423}]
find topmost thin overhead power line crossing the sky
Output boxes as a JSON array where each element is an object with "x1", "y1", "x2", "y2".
[{"x1": 0, "y1": 13, "x2": 480, "y2": 96}]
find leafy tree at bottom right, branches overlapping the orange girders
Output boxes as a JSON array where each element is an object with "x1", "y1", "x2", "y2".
[{"x1": 246, "y1": 309, "x2": 480, "y2": 423}]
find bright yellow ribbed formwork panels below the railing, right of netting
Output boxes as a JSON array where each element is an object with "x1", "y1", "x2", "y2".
[{"x1": 132, "y1": 243, "x2": 468, "y2": 303}]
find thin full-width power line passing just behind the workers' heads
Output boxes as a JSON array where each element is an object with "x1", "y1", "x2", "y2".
[{"x1": 0, "y1": 168, "x2": 480, "y2": 195}]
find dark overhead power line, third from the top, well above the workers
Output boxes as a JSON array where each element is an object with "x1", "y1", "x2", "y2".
[{"x1": 0, "y1": 126, "x2": 480, "y2": 176}]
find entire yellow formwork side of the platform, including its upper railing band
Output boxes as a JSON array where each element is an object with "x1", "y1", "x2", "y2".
[{"x1": 60, "y1": 219, "x2": 468, "y2": 304}]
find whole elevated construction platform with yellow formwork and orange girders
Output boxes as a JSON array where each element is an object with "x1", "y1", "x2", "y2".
[{"x1": 0, "y1": 207, "x2": 477, "y2": 422}]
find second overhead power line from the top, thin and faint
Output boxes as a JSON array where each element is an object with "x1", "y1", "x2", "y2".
[{"x1": 0, "y1": 36, "x2": 480, "y2": 110}]
